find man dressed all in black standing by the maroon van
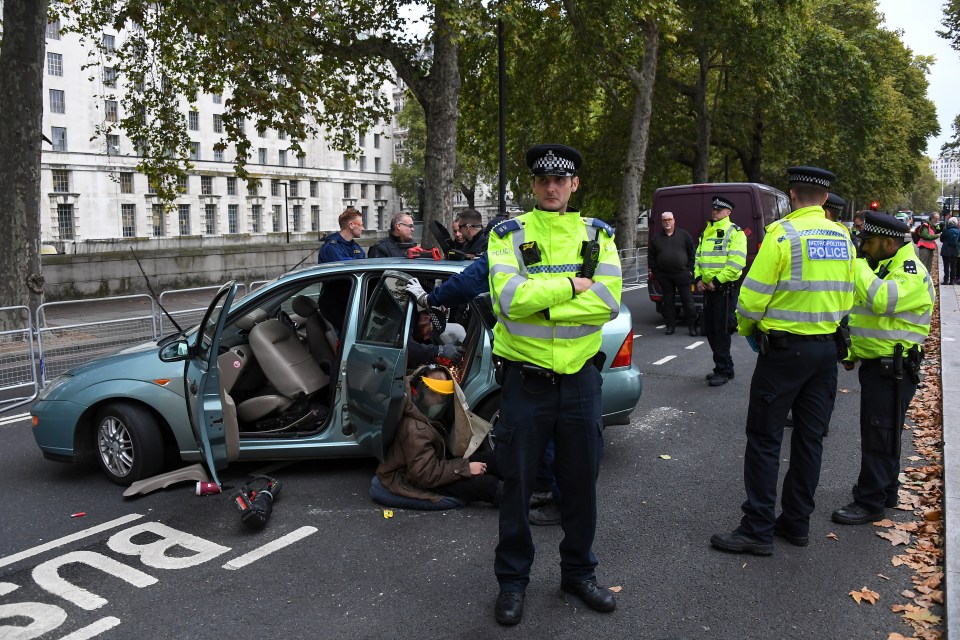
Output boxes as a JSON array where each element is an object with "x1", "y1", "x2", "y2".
[{"x1": 647, "y1": 211, "x2": 697, "y2": 336}]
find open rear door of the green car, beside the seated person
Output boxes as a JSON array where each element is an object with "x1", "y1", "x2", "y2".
[{"x1": 344, "y1": 271, "x2": 413, "y2": 460}]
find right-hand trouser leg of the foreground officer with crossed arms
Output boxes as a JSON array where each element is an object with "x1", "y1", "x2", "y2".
[{"x1": 554, "y1": 364, "x2": 603, "y2": 584}]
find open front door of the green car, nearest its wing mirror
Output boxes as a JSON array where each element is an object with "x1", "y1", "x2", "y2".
[{"x1": 183, "y1": 281, "x2": 237, "y2": 485}]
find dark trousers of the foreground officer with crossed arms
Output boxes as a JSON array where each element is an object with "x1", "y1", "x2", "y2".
[{"x1": 493, "y1": 361, "x2": 603, "y2": 591}]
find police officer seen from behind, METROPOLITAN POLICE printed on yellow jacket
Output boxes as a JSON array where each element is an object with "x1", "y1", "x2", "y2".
[{"x1": 710, "y1": 167, "x2": 854, "y2": 556}]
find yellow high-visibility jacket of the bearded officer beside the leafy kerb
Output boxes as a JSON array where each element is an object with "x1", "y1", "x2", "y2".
[{"x1": 847, "y1": 243, "x2": 936, "y2": 362}]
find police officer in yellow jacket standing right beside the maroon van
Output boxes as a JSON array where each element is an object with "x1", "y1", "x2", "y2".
[{"x1": 693, "y1": 196, "x2": 747, "y2": 387}]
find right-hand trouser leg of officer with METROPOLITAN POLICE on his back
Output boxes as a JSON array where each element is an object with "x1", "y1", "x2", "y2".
[{"x1": 780, "y1": 336, "x2": 837, "y2": 536}]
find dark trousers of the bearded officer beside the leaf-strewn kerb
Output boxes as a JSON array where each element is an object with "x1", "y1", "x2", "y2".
[{"x1": 853, "y1": 360, "x2": 917, "y2": 513}]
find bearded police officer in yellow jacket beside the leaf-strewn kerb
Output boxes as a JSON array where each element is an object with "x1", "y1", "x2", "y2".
[{"x1": 832, "y1": 211, "x2": 935, "y2": 524}]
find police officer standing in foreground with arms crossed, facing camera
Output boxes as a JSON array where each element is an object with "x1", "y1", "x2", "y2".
[{"x1": 487, "y1": 144, "x2": 623, "y2": 625}]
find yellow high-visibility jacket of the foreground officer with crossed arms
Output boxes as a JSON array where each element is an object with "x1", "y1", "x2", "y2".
[{"x1": 487, "y1": 209, "x2": 623, "y2": 373}]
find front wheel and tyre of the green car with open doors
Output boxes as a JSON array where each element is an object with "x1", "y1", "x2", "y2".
[{"x1": 94, "y1": 402, "x2": 163, "y2": 486}]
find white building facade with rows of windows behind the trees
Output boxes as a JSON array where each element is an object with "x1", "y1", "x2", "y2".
[{"x1": 41, "y1": 18, "x2": 400, "y2": 246}]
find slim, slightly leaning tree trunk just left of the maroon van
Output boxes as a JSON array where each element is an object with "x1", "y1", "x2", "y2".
[{"x1": 616, "y1": 20, "x2": 659, "y2": 249}]
